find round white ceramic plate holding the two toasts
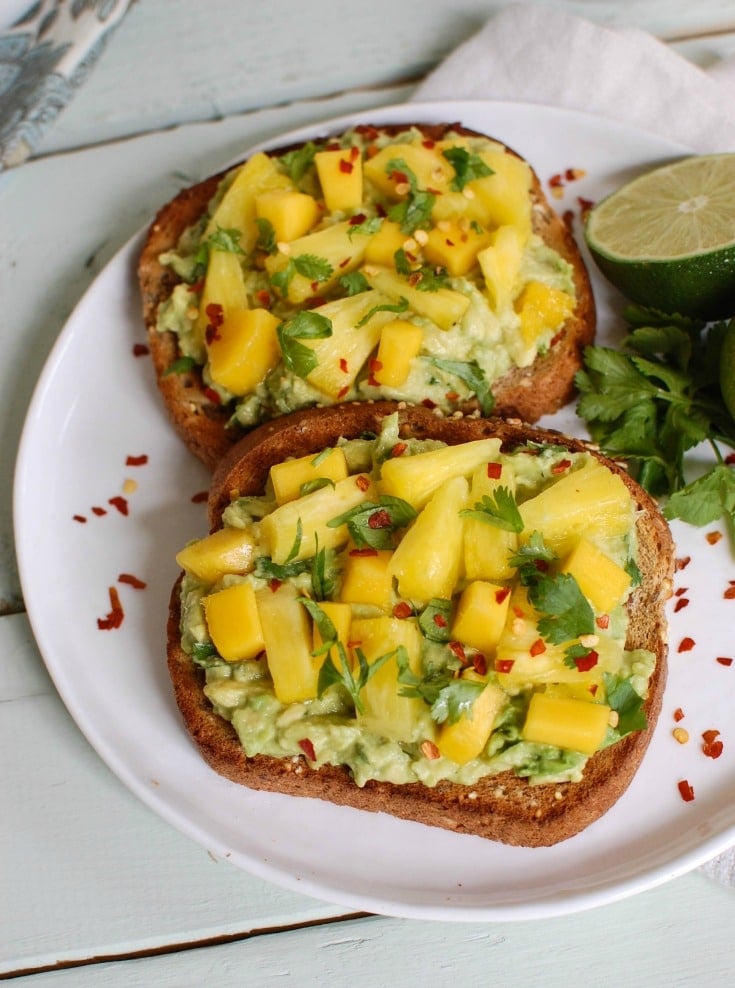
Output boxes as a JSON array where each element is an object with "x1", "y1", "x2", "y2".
[{"x1": 15, "y1": 102, "x2": 735, "y2": 920}]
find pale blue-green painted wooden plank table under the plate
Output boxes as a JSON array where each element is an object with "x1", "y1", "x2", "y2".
[{"x1": 0, "y1": 0, "x2": 735, "y2": 988}]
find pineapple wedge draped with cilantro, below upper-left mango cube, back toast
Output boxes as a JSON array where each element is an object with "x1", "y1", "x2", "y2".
[{"x1": 265, "y1": 221, "x2": 370, "y2": 303}]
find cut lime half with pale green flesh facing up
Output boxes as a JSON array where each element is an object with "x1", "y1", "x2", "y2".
[{"x1": 585, "y1": 154, "x2": 735, "y2": 319}]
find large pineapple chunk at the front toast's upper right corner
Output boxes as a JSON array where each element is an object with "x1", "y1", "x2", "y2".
[{"x1": 519, "y1": 457, "x2": 634, "y2": 557}]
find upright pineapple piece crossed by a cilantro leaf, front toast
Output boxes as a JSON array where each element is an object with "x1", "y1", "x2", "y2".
[{"x1": 464, "y1": 463, "x2": 518, "y2": 583}]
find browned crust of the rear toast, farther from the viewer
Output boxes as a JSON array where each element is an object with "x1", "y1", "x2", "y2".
[{"x1": 138, "y1": 123, "x2": 595, "y2": 469}]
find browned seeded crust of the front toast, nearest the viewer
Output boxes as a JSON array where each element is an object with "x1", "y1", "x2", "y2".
[{"x1": 168, "y1": 402, "x2": 674, "y2": 847}]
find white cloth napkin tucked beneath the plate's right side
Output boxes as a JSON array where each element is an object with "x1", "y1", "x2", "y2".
[{"x1": 412, "y1": 3, "x2": 735, "y2": 886}]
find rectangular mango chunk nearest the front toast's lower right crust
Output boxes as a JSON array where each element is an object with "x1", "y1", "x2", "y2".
[{"x1": 521, "y1": 693, "x2": 610, "y2": 755}]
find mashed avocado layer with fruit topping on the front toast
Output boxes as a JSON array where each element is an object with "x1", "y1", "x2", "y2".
[{"x1": 177, "y1": 416, "x2": 655, "y2": 786}]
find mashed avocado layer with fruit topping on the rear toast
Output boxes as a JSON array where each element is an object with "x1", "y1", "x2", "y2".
[{"x1": 158, "y1": 127, "x2": 576, "y2": 427}]
